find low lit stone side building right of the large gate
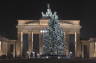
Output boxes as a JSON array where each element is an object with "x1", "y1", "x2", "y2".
[{"x1": 80, "y1": 38, "x2": 96, "y2": 58}]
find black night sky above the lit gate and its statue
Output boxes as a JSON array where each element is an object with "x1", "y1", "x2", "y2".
[{"x1": 0, "y1": 0, "x2": 96, "y2": 39}]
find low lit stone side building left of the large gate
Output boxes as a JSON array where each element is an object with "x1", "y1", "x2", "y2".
[{"x1": 0, "y1": 36, "x2": 16, "y2": 57}]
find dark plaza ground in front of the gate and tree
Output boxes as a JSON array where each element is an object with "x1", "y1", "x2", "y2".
[{"x1": 0, "y1": 58, "x2": 96, "y2": 63}]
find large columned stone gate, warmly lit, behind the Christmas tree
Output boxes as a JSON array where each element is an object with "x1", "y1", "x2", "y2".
[{"x1": 16, "y1": 19, "x2": 81, "y2": 56}]
